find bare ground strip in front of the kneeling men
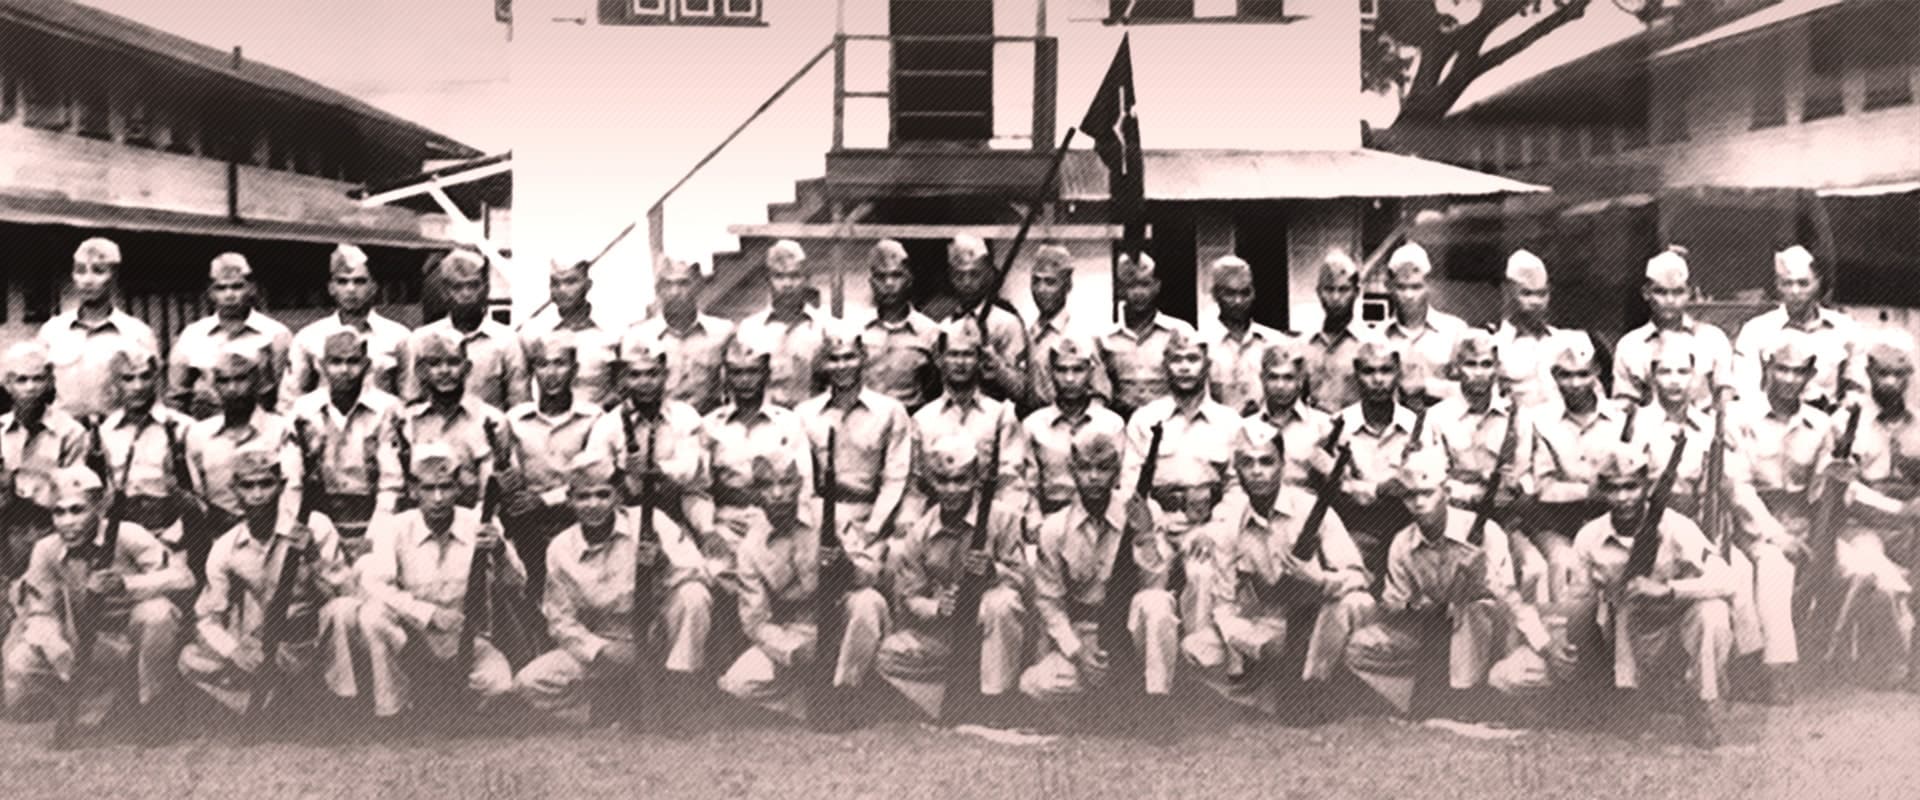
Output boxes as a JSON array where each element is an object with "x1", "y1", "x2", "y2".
[{"x1": 0, "y1": 675, "x2": 1920, "y2": 800}]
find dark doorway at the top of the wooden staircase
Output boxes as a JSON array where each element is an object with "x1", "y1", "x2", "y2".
[{"x1": 887, "y1": 0, "x2": 993, "y2": 146}]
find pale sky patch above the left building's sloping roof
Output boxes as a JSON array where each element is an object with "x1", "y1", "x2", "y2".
[{"x1": 83, "y1": 0, "x2": 513, "y2": 153}]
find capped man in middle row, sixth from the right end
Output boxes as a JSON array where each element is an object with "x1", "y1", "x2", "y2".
[{"x1": 1334, "y1": 340, "x2": 1436, "y2": 583}]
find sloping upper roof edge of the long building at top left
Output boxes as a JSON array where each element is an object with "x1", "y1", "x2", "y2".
[{"x1": 0, "y1": 0, "x2": 480, "y2": 157}]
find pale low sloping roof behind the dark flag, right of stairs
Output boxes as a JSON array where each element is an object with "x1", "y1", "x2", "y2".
[{"x1": 1060, "y1": 150, "x2": 1549, "y2": 201}]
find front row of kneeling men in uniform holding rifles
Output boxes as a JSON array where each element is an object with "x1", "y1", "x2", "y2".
[{"x1": 6, "y1": 404, "x2": 1758, "y2": 742}]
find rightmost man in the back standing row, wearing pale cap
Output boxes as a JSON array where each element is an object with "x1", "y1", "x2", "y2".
[{"x1": 1734, "y1": 246, "x2": 1866, "y2": 412}]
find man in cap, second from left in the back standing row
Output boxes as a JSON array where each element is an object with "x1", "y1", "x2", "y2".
[{"x1": 167, "y1": 253, "x2": 294, "y2": 420}]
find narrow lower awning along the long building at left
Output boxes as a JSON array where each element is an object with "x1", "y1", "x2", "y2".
[{"x1": 0, "y1": 196, "x2": 453, "y2": 249}]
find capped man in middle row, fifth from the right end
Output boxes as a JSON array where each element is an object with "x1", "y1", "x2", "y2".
[{"x1": 1427, "y1": 330, "x2": 1548, "y2": 599}]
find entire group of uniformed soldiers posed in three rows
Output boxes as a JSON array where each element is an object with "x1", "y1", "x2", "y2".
[{"x1": 0, "y1": 229, "x2": 1920, "y2": 746}]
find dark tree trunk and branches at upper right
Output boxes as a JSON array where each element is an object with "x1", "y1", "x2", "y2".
[{"x1": 1361, "y1": 0, "x2": 1597, "y2": 125}]
